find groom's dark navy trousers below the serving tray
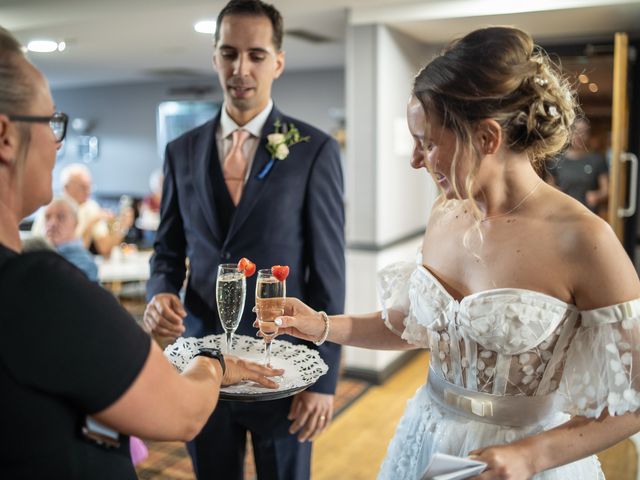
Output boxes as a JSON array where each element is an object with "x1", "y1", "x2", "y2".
[{"x1": 187, "y1": 397, "x2": 311, "y2": 480}]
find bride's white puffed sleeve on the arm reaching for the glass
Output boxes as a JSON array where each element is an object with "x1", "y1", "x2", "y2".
[{"x1": 378, "y1": 262, "x2": 429, "y2": 348}]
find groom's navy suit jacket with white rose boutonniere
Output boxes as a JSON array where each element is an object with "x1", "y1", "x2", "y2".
[{"x1": 147, "y1": 107, "x2": 345, "y2": 393}]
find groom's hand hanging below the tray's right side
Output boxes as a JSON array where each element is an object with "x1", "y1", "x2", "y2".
[{"x1": 287, "y1": 391, "x2": 333, "y2": 442}]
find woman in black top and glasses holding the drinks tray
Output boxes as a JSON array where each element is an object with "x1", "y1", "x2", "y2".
[{"x1": 0, "y1": 27, "x2": 282, "y2": 479}]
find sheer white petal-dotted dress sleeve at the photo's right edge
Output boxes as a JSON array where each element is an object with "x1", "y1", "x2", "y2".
[{"x1": 559, "y1": 299, "x2": 640, "y2": 417}]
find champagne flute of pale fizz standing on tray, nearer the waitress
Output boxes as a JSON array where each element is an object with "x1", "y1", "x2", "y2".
[{"x1": 216, "y1": 263, "x2": 247, "y2": 354}]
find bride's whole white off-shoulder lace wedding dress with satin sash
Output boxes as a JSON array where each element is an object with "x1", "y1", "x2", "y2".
[{"x1": 378, "y1": 263, "x2": 640, "y2": 480}]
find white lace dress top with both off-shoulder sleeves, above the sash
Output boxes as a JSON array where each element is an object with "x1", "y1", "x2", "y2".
[{"x1": 379, "y1": 263, "x2": 640, "y2": 416}]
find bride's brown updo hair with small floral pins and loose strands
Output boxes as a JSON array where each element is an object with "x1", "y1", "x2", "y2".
[{"x1": 413, "y1": 27, "x2": 576, "y2": 204}]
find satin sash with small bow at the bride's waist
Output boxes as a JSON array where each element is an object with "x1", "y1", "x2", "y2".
[{"x1": 427, "y1": 370, "x2": 556, "y2": 427}]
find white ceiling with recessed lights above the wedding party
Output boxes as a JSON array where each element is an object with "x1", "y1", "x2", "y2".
[{"x1": 0, "y1": 0, "x2": 640, "y2": 87}]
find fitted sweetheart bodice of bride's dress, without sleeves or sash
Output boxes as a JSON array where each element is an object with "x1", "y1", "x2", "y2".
[{"x1": 409, "y1": 265, "x2": 578, "y2": 395}]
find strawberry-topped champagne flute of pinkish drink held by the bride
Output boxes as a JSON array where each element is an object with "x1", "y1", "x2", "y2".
[{"x1": 256, "y1": 270, "x2": 287, "y2": 366}]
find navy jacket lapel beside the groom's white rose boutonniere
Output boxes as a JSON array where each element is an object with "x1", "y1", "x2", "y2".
[{"x1": 226, "y1": 107, "x2": 281, "y2": 242}]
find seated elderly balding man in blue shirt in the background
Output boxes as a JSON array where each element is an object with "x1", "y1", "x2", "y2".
[{"x1": 44, "y1": 196, "x2": 98, "y2": 282}]
